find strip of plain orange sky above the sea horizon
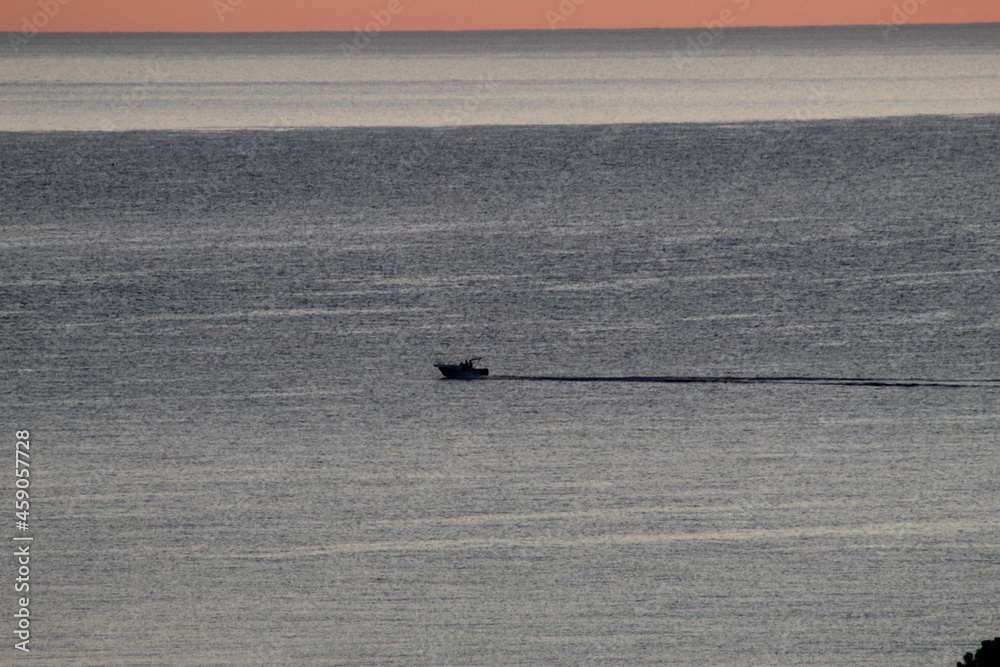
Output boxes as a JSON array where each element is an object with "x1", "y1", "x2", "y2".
[{"x1": 0, "y1": 0, "x2": 1000, "y2": 32}]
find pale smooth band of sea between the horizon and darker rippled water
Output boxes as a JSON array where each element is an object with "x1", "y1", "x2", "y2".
[{"x1": 0, "y1": 24, "x2": 1000, "y2": 131}]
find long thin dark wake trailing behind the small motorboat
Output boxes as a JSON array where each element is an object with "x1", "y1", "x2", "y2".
[{"x1": 490, "y1": 375, "x2": 1000, "y2": 388}]
